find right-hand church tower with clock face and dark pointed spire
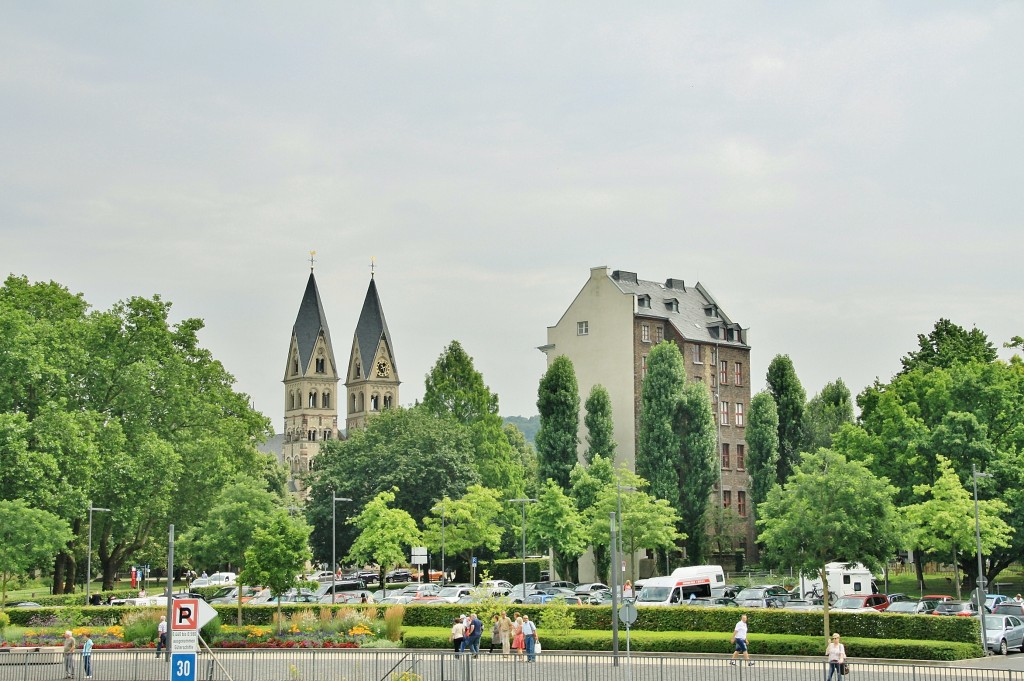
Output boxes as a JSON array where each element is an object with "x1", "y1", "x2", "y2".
[{"x1": 345, "y1": 274, "x2": 400, "y2": 432}]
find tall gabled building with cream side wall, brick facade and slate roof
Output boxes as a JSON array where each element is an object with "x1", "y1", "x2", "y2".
[{"x1": 541, "y1": 267, "x2": 756, "y2": 553}]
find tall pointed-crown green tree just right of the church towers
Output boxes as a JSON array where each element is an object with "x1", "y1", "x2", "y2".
[{"x1": 422, "y1": 341, "x2": 524, "y2": 497}]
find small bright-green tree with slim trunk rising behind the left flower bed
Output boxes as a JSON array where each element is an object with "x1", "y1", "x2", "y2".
[{"x1": 239, "y1": 509, "x2": 312, "y2": 634}]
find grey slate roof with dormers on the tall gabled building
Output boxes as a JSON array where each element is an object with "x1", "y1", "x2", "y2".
[{"x1": 611, "y1": 269, "x2": 746, "y2": 347}]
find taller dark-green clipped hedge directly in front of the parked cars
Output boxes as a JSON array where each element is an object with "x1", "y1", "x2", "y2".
[{"x1": 397, "y1": 605, "x2": 981, "y2": 643}]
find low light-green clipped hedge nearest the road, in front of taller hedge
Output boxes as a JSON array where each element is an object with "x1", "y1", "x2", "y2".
[{"x1": 402, "y1": 627, "x2": 981, "y2": 661}]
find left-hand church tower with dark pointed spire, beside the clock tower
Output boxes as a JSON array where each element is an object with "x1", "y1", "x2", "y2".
[{"x1": 282, "y1": 266, "x2": 340, "y2": 497}]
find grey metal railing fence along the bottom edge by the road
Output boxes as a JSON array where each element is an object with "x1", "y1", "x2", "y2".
[{"x1": 0, "y1": 648, "x2": 1024, "y2": 681}]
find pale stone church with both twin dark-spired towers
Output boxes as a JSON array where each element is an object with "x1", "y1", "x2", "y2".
[{"x1": 278, "y1": 267, "x2": 400, "y2": 497}]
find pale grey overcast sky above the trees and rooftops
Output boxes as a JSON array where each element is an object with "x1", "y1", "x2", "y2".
[{"x1": 0, "y1": 0, "x2": 1024, "y2": 430}]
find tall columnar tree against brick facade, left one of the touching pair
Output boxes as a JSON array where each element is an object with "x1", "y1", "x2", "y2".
[{"x1": 636, "y1": 341, "x2": 686, "y2": 499}]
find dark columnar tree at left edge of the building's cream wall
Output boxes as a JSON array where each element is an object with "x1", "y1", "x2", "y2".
[{"x1": 537, "y1": 354, "x2": 580, "y2": 490}]
